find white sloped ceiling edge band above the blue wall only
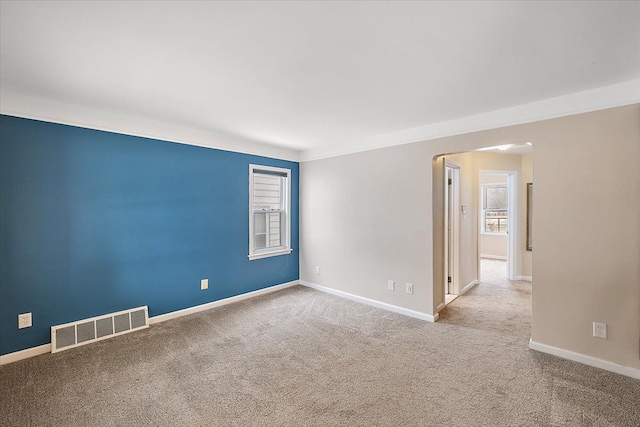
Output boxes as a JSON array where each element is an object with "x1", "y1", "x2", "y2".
[{"x1": 0, "y1": 88, "x2": 299, "y2": 162}]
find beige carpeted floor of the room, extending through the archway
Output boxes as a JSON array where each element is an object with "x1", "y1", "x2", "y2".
[{"x1": 0, "y1": 260, "x2": 640, "y2": 427}]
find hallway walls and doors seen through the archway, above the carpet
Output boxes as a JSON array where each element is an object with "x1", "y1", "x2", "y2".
[{"x1": 431, "y1": 143, "x2": 533, "y2": 320}]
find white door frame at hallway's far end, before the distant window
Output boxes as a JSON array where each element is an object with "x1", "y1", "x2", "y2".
[{"x1": 478, "y1": 169, "x2": 519, "y2": 280}]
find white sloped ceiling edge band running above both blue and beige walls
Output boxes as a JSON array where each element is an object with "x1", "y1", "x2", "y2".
[{"x1": 0, "y1": 79, "x2": 640, "y2": 162}]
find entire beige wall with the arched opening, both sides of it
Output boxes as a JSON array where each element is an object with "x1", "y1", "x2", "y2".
[{"x1": 300, "y1": 104, "x2": 640, "y2": 368}]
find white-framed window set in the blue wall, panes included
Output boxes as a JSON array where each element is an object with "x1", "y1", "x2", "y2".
[{"x1": 249, "y1": 165, "x2": 291, "y2": 260}]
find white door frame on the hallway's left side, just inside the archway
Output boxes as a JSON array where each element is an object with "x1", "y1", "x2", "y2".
[{"x1": 444, "y1": 158, "x2": 460, "y2": 295}]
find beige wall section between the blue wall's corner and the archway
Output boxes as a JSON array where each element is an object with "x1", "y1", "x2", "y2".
[{"x1": 300, "y1": 144, "x2": 433, "y2": 313}]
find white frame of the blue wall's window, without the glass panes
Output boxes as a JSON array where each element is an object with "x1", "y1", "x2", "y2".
[{"x1": 247, "y1": 164, "x2": 293, "y2": 260}]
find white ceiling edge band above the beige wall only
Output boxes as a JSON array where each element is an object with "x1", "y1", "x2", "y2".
[{"x1": 300, "y1": 79, "x2": 640, "y2": 162}]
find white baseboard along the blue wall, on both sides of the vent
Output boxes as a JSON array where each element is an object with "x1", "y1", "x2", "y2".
[{"x1": 0, "y1": 280, "x2": 300, "y2": 366}]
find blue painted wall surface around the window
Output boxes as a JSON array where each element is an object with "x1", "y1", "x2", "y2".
[{"x1": 0, "y1": 116, "x2": 299, "y2": 354}]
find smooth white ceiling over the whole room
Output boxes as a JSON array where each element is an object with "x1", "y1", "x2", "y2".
[{"x1": 0, "y1": 1, "x2": 640, "y2": 162}]
